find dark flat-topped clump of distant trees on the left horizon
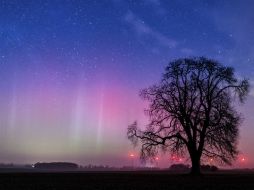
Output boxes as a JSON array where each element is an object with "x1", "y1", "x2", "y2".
[{"x1": 34, "y1": 162, "x2": 79, "y2": 170}]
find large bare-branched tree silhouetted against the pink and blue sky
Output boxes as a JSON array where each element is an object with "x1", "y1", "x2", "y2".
[{"x1": 127, "y1": 57, "x2": 249, "y2": 174}]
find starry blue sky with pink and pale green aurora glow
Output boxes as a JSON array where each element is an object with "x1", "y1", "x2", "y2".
[{"x1": 0, "y1": 0, "x2": 254, "y2": 167}]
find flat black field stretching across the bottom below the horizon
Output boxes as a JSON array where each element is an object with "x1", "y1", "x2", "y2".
[{"x1": 0, "y1": 172, "x2": 254, "y2": 190}]
